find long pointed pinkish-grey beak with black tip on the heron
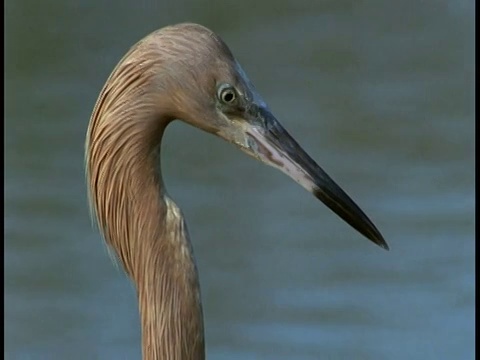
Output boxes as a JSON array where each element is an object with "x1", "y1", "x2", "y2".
[{"x1": 245, "y1": 107, "x2": 388, "y2": 250}]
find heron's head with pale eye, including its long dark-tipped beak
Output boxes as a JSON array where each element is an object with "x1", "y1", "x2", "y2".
[{"x1": 156, "y1": 24, "x2": 388, "y2": 249}]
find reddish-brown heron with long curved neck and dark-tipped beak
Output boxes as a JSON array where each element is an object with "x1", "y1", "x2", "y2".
[{"x1": 85, "y1": 23, "x2": 388, "y2": 360}]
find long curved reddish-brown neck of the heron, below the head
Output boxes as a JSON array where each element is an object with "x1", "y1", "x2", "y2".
[{"x1": 87, "y1": 60, "x2": 205, "y2": 360}]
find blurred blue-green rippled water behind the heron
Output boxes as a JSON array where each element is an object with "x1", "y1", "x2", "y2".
[{"x1": 4, "y1": 0, "x2": 475, "y2": 360}]
